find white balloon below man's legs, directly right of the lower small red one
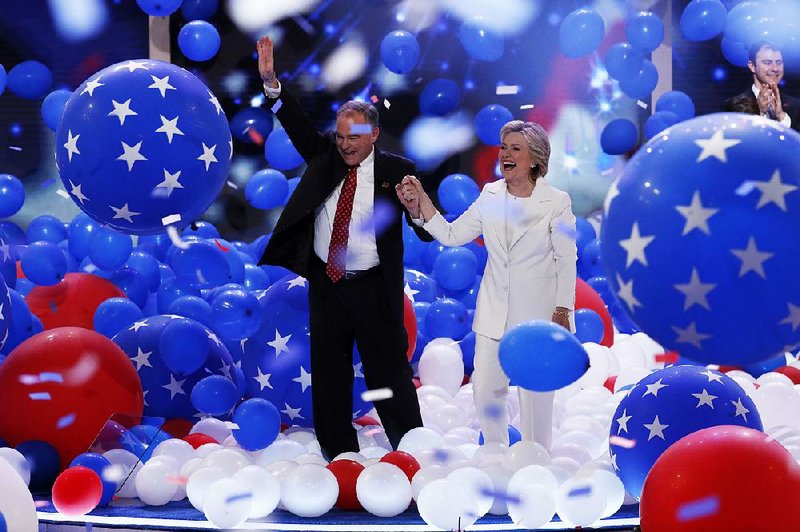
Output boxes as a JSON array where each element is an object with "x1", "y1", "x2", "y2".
[{"x1": 356, "y1": 462, "x2": 411, "y2": 517}]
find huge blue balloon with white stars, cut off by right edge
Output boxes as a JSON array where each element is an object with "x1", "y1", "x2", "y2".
[{"x1": 601, "y1": 113, "x2": 800, "y2": 365}]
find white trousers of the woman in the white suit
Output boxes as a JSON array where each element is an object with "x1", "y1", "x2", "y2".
[{"x1": 472, "y1": 334, "x2": 555, "y2": 451}]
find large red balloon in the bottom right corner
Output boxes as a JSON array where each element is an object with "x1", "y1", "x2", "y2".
[{"x1": 639, "y1": 425, "x2": 800, "y2": 532}]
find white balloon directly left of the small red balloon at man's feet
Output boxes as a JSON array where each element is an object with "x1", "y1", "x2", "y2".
[{"x1": 281, "y1": 464, "x2": 339, "y2": 517}]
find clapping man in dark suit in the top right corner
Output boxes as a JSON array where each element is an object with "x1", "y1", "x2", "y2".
[{"x1": 722, "y1": 41, "x2": 800, "y2": 131}]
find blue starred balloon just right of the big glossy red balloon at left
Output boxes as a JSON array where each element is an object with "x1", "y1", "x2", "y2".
[{"x1": 113, "y1": 315, "x2": 240, "y2": 421}]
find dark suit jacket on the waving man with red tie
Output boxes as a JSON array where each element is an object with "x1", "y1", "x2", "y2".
[{"x1": 259, "y1": 85, "x2": 433, "y2": 323}]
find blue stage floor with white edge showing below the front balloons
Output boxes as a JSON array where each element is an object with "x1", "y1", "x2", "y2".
[{"x1": 37, "y1": 500, "x2": 639, "y2": 532}]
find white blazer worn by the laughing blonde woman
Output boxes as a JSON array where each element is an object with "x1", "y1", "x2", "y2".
[{"x1": 423, "y1": 179, "x2": 577, "y2": 339}]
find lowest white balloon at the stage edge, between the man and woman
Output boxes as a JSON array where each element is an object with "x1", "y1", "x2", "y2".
[{"x1": 417, "y1": 478, "x2": 478, "y2": 530}]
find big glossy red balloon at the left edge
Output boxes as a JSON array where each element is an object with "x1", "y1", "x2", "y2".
[{"x1": 0, "y1": 327, "x2": 144, "y2": 467}]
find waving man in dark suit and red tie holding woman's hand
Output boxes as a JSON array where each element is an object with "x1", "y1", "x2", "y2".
[{"x1": 257, "y1": 37, "x2": 433, "y2": 459}]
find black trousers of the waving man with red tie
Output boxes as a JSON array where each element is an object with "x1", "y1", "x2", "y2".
[{"x1": 308, "y1": 257, "x2": 422, "y2": 459}]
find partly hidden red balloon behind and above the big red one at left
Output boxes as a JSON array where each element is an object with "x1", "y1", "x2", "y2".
[{"x1": 25, "y1": 272, "x2": 127, "y2": 330}]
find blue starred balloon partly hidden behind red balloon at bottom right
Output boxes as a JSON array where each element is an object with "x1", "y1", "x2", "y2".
[{"x1": 609, "y1": 366, "x2": 763, "y2": 498}]
